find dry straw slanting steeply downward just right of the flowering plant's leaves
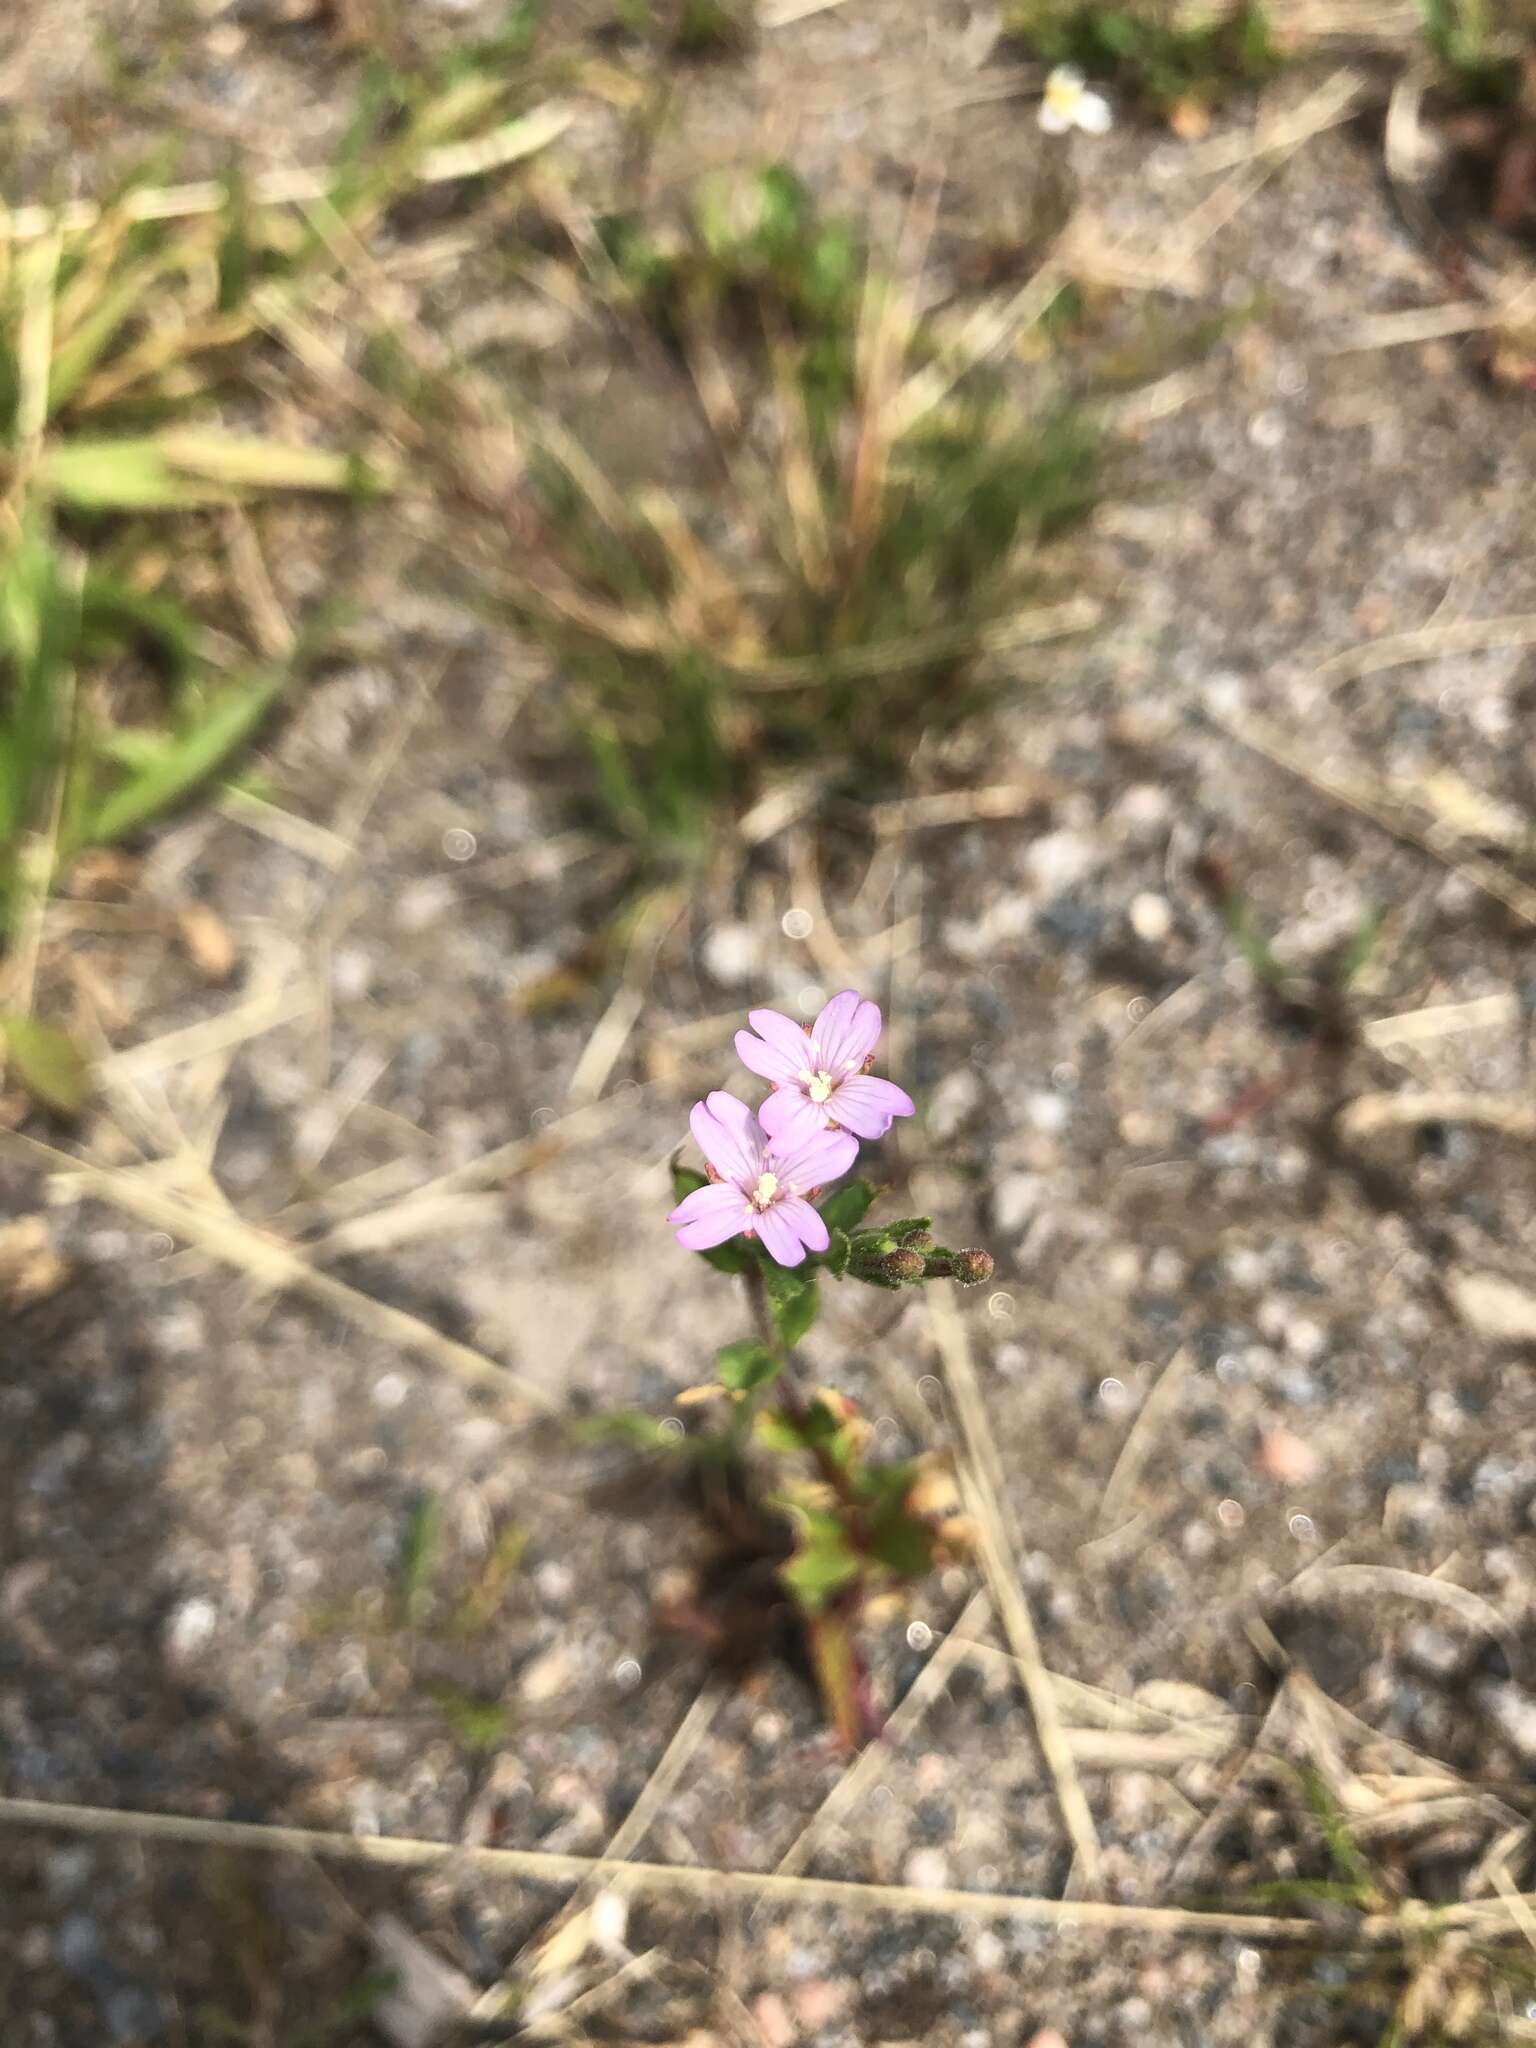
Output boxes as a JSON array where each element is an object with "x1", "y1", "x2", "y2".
[{"x1": 928, "y1": 1288, "x2": 1100, "y2": 1890}]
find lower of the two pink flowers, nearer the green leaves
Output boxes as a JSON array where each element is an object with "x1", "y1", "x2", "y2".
[{"x1": 668, "y1": 1090, "x2": 858, "y2": 1266}]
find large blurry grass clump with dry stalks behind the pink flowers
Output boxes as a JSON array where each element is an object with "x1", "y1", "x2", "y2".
[{"x1": 475, "y1": 166, "x2": 1094, "y2": 864}]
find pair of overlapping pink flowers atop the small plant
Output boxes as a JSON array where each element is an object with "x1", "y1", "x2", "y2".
[{"x1": 668, "y1": 989, "x2": 913, "y2": 1266}]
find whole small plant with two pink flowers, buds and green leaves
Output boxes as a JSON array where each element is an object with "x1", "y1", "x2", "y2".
[{"x1": 625, "y1": 989, "x2": 993, "y2": 1747}]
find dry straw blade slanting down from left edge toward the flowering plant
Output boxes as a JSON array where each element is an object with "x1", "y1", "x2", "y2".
[{"x1": 0, "y1": 1133, "x2": 559, "y2": 1413}]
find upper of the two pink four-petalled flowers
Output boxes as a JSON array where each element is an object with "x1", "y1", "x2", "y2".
[{"x1": 735, "y1": 989, "x2": 913, "y2": 1139}]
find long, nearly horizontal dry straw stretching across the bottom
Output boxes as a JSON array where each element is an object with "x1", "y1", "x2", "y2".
[{"x1": 0, "y1": 1798, "x2": 1327, "y2": 1942}]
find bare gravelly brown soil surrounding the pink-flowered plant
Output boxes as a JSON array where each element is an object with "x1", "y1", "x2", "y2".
[{"x1": 0, "y1": 0, "x2": 1536, "y2": 2048}]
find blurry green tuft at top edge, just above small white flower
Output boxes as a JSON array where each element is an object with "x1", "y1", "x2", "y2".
[{"x1": 1004, "y1": 0, "x2": 1286, "y2": 115}]
